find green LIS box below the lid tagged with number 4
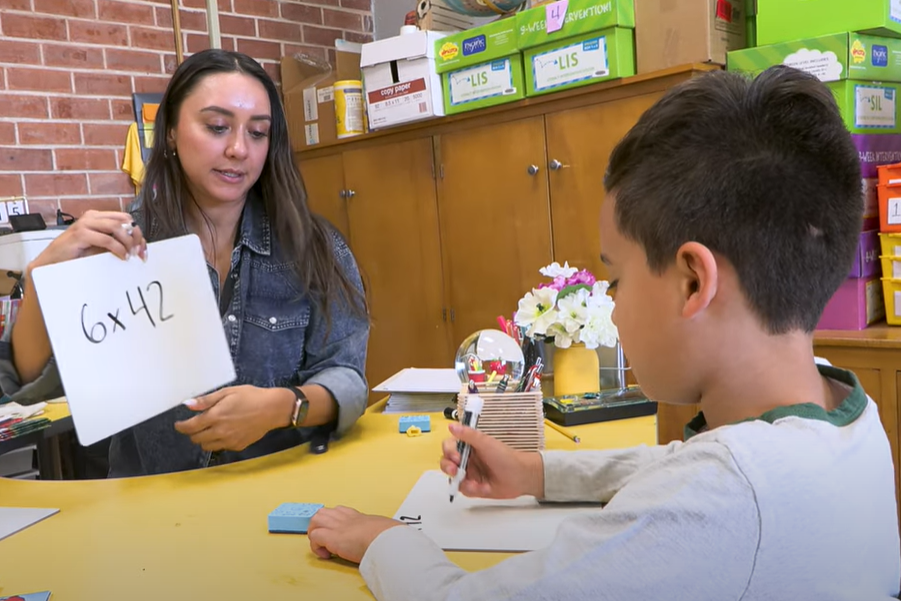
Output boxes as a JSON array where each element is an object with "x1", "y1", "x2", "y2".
[{"x1": 523, "y1": 27, "x2": 635, "y2": 96}]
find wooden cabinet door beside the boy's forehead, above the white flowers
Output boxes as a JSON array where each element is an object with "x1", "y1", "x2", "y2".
[{"x1": 546, "y1": 93, "x2": 661, "y2": 279}]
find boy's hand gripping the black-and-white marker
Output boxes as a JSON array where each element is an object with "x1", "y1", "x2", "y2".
[{"x1": 440, "y1": 424, "x2": 544, "y2": 499}]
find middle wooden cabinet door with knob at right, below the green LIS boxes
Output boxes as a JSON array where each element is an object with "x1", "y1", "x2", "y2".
[{"x1": 438, "y1": 117, "x2": 551, "y2": 346}]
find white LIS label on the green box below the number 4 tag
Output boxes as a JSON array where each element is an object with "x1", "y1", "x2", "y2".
[{"x1": 532, "y1": 36, "x2": 610, "y2": 90}]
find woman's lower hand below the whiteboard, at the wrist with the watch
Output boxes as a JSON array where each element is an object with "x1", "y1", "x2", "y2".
[{"x1": 175, "y1": 386, "x2": 291, "y2": 451}]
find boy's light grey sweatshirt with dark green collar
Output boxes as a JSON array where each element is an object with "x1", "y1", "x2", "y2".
[{"x1": 360, "y1": 366, "x2": 901, "y2": 601}]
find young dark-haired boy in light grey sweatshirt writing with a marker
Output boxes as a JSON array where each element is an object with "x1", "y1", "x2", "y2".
[{"x1": 310, "y1": 67, "x2": 901, "y2": 601}]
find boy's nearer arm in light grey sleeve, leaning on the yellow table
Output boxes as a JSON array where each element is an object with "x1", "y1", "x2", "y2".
[{"x1": 360, "y1": 443, "x2": 760, "y2": 601}]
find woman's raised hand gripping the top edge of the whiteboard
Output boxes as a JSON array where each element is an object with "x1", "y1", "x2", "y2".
[{"x1": 28, "y1": 211, "x2": 147, "y2": 272}]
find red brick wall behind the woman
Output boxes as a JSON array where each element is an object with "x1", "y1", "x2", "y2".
[{"x1": 0, "y1": 0, "x2": 372, "y2": 221}]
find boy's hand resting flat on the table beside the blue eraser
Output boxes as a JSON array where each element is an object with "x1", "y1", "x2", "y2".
[{"x1": 307, "y1": 506, "x2": 406, "y2": 563}]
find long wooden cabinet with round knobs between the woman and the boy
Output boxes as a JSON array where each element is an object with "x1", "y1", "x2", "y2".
[{"x1": 296, "y1": 65, "x2": 715, "y2": 400}]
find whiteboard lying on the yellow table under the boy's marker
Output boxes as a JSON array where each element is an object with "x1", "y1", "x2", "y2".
[{"x1": 394, "y1": 470, "x2": 603, "y2": 552}]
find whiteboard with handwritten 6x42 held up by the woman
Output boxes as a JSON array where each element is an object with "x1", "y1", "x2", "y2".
[{"x1": 32, "y1": 234, "x2": 235, "y2": 445}]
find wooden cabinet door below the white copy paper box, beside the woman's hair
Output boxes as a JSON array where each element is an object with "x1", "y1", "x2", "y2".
[{"x1": 344, "y1": 138, "x2": 453, "y2": 396}]
